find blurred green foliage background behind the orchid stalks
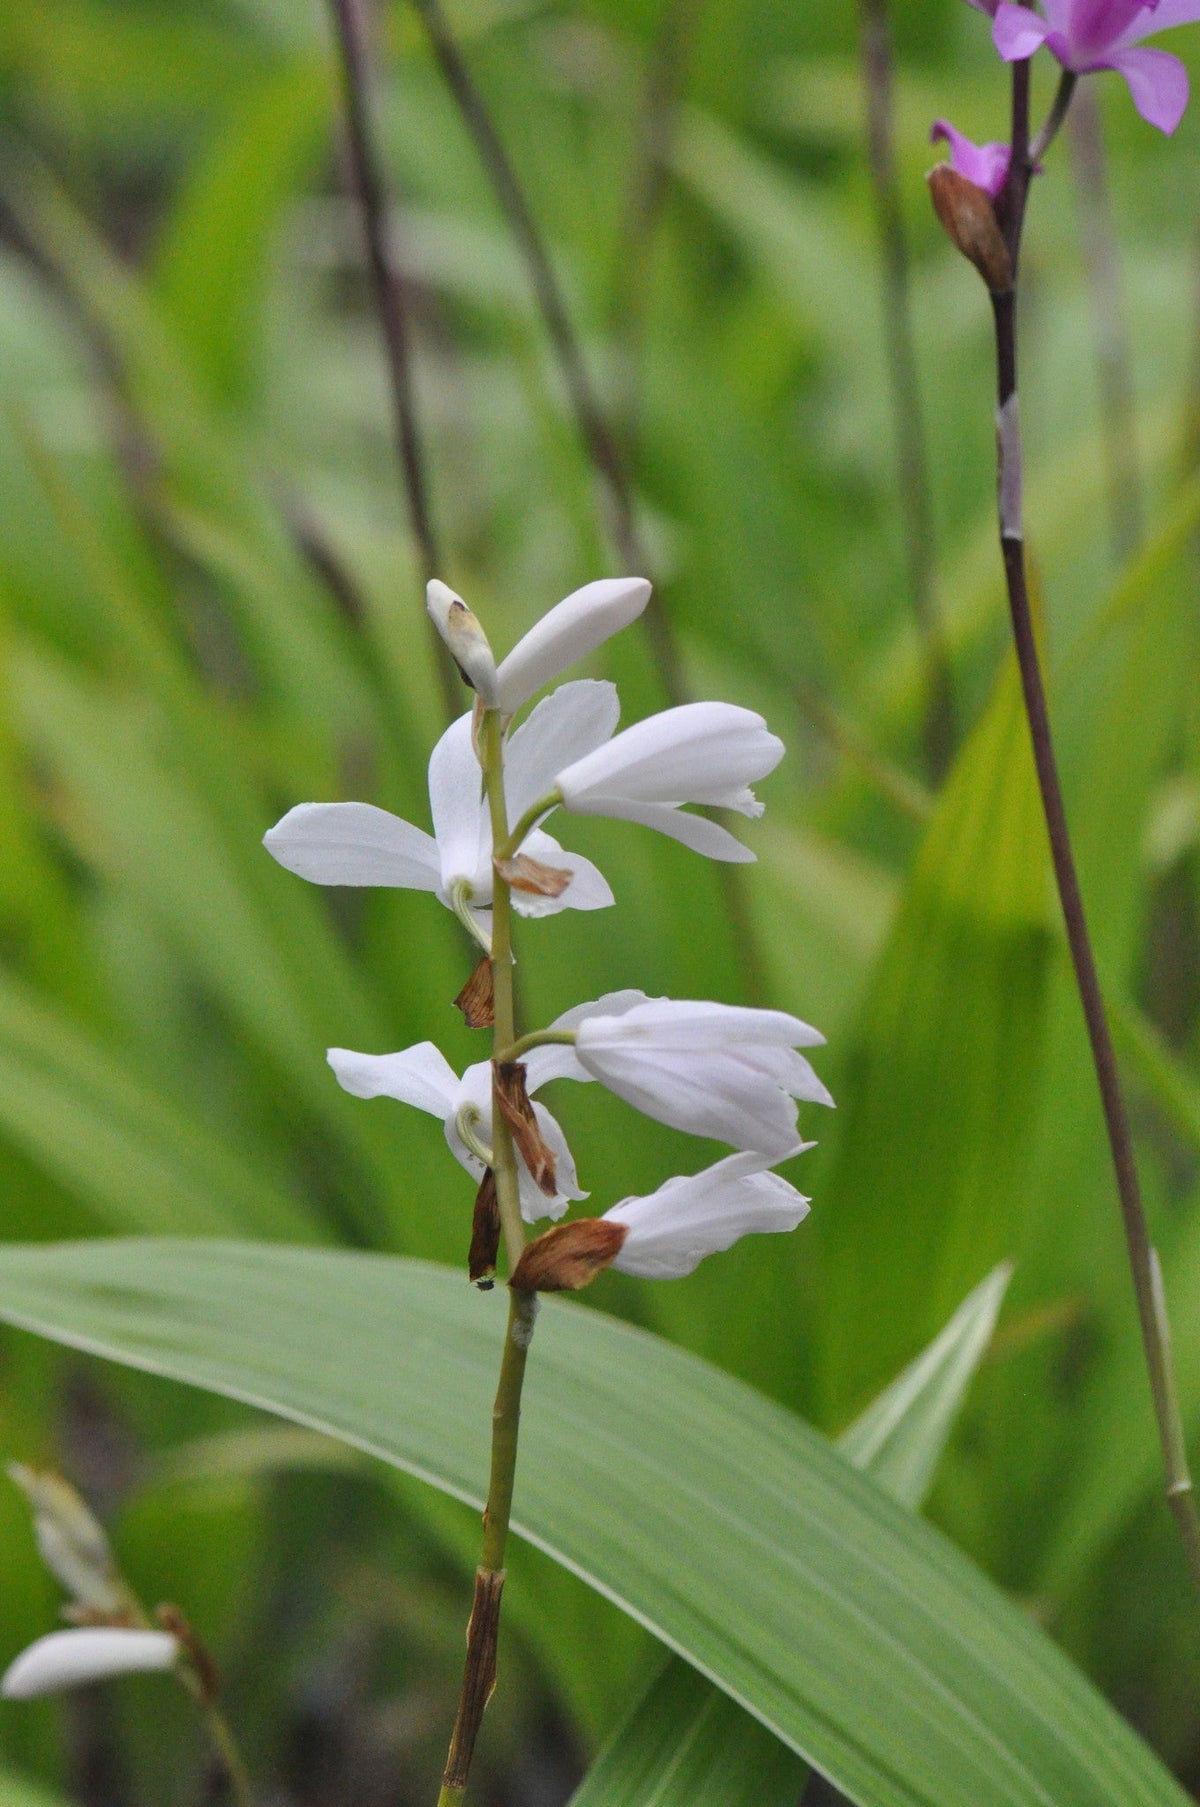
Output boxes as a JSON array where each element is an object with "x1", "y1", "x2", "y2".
[{"x1": 0, "y1": 0, "x2": 1200, "y2": 1807}]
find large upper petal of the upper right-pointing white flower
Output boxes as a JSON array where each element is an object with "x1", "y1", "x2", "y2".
[{"x1": 558, "y1": 703, "x2": 784, "y2": 808}]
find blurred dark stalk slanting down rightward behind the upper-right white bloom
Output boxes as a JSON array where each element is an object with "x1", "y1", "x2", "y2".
[{"x1": 404, "y1": 0, "x2": 685, "y2": 703}]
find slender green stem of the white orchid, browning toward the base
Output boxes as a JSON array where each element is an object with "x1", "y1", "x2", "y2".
[{"x1": 437, "y1": 710, "x2": 540, "y2": 1807}]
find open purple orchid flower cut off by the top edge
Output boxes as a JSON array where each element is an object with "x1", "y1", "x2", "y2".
[{"x1": 972, "y1": 0, "x2": 1200, "y2": 132}]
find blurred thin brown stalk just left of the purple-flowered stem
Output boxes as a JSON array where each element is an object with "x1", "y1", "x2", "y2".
[{"x1": 860, "y1": 0, "x2": 954, "y2": 786}]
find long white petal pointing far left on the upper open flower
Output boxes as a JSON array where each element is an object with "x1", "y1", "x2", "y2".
[{"x1": 262, "y1": 802, "x2": 441, "y2": 891}]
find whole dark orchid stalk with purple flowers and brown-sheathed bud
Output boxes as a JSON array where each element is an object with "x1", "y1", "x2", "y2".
[{"x1": 934, "y1": 0, "x2": 1200, "y2": 1588}]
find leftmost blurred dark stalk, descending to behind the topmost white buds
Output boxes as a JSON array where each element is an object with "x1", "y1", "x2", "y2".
[{"x1": 329, "y1": 0, "x2": 463, "y2": 719}]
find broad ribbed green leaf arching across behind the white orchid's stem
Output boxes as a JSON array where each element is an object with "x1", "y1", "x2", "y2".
[{"x1": 0, "y1": 1241, "x2": 1186, "y2": 1807}]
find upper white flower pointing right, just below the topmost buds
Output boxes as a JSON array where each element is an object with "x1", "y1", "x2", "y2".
[{"x1": 555, "y1": 703, "x2": 784, "y2": 862}]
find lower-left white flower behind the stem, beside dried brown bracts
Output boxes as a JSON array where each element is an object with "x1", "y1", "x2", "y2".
[{"x1": 329, "y1": 1041, "x2": 587, "y2": 1223}]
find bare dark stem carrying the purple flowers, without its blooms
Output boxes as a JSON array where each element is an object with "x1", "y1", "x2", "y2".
[{"x1": 992, "y1": 63, "x2": 1200, "y2": 1587}]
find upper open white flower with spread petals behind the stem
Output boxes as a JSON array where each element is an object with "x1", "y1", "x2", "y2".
[{"x1": 264, "y1": 675, "x2": 620, "y2": 938}]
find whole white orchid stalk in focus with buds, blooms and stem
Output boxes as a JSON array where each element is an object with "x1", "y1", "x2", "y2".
[{"x1": 264, "y1": 578, "x2": 833, "y2": 1807}]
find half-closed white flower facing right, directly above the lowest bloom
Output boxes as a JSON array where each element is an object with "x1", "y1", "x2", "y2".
[{"x1": 524, "y1": 992, "x2": 833, "y2": 1164}]
